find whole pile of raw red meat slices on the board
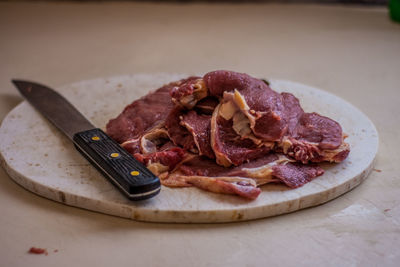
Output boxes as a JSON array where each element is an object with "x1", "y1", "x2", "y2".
[{"x1": 107, "y1": 70, "x2": 350, "y2": 199}]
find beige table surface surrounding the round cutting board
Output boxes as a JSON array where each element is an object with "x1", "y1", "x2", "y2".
[{"x1": 0, "y1": 2, "x2": 400, "y2": 266}]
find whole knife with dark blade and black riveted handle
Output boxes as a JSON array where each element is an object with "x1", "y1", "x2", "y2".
[{"x1": 12, "y1": 80, "x2": 161, "y2": 200}]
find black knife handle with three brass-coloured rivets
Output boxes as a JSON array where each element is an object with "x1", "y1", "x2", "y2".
[{"x1": 74, "y1": 129, "x2": 161, "y2": 200}]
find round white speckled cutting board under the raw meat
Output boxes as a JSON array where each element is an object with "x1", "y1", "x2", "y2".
[{"x1": 0, "y1": 74, "x2": 378, "y2": 223}]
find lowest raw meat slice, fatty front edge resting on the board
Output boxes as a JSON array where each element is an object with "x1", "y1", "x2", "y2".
[{"x1": 161, "y1": 154, "x2": 324, "y2": 199}]
